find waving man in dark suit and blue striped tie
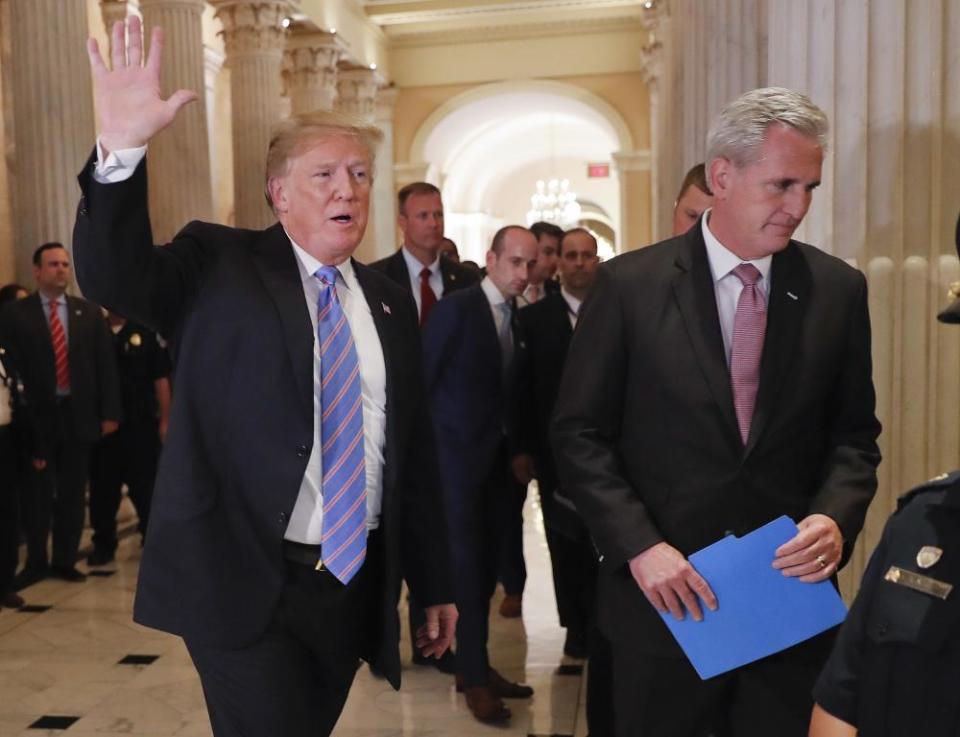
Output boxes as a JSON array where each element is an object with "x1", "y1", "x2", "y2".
[{"x1": 74, "y1": 17, "x2": 456, "y2": 736}]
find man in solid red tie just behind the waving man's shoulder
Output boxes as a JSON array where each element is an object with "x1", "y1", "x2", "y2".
[{"x1": 370, "y1": 182, "x2": 478, "y2": 326}]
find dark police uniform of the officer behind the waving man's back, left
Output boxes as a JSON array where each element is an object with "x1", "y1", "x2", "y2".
[{"x1": 87, "y1": 321, "x2": 170, "y2": 565}]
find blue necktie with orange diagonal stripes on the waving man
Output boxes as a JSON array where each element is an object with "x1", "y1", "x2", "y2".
[{"x1": 315, "y1": 266, "x2": 367, "y2": 584}]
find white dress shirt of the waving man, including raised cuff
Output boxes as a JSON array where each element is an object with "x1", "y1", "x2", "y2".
[{"x1": 94, "y1": 140, "x2": 388, "y2": 545}]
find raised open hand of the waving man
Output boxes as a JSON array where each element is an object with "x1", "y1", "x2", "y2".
[{"x1": 87, "y1": 16, "x2": 197, "y2": 154}]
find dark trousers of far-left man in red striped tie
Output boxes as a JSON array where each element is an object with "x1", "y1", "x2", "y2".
[{"x1": 23, "y1": 399, "x2": 90, "y2": 569}]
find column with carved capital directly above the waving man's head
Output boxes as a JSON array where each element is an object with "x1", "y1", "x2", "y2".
[{"x1": 283, "y1": 23, "x2": 343, "y2": 115}]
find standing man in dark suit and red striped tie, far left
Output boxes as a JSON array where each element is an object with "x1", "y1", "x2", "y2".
[{"x1": 0, "y1": 243, "x2": 122, "y2": 587}]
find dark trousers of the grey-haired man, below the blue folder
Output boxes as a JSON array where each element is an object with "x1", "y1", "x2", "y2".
[{"x1": 612, "y1": 629, "x2": 836, "y2": 737}]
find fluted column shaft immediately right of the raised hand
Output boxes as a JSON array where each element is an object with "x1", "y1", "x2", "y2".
[{"x1": 140, "y1": 0, "x2": 213, "y2": 243}]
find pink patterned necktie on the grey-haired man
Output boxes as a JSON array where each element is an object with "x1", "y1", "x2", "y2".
[{"x1": 730, "y1": 264, "x2": 767, "y2": 445}]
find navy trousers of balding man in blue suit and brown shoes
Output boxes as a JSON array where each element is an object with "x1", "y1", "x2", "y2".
[{"x1": 445, "y1": 453, "x2": 507, "y2": 686}]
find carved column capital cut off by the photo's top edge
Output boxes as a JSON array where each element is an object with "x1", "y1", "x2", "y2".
[{"x1": 210, "y1": 0, "x2": 294, "y2": 59}]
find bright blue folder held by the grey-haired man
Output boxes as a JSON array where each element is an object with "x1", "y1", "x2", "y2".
[{"x1": 661, "y1": 517, "x2": 847, "y2": 679}]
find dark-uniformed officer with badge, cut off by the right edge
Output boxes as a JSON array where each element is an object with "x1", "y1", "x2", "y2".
[{"x1": 810, "y1": 221, "x2": 960, "y2": 737}]
